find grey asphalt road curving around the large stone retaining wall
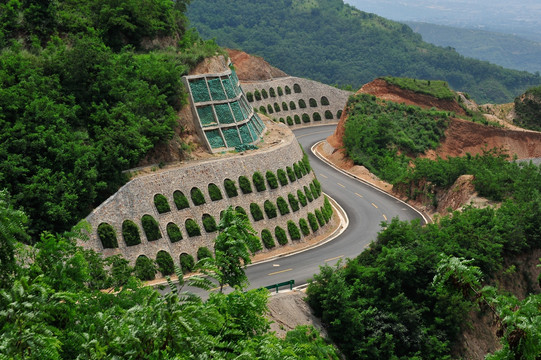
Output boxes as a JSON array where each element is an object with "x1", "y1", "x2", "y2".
[{"x1": 240, "y1": 125, "x2": 421, "y2": 289}]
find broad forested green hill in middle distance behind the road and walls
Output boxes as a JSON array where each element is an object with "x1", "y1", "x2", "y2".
[{"x1": 188, "y1": 0, "x2": 541, "y2": 103}]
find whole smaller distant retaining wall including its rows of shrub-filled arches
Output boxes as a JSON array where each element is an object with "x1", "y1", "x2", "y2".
[{"x1": 241, "y1": 76, "x2": 353, "y2": 126}]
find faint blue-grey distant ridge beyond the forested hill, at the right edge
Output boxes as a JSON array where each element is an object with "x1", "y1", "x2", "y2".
[{"x1": 403, "y1": 21, "x2": 541, "y2": 73}]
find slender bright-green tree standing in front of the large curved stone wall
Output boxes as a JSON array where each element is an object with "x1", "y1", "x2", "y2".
[{"x1": 214, "y1": 206, "x2": 256, "y2": 292}]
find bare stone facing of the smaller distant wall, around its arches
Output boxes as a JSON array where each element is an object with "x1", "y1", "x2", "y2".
[{"x1": 241, "y1": 76, "x2": 353, "y2": 127}]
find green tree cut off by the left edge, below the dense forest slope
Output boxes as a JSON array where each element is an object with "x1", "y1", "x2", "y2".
[{"x1": 0, "y1": 190, "x2": 27, "y2": 288}]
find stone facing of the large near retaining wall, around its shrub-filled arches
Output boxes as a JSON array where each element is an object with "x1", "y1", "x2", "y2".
[{"x1": 81, "y1": 128, "x2": 324, "y2": 264}]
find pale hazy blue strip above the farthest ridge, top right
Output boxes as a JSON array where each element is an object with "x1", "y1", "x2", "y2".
[{"x1": 345, "y1": 0, "x2": 541, "y2": 37}]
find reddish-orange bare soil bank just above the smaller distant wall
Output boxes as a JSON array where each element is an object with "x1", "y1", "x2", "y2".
[{"x1": 227, "y1": 49, "x2": 288, "y2": 81}]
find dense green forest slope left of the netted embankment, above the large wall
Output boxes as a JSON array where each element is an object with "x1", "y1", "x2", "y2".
[{"x1": 0, "y1": 0, "x2": 223, "y2": 240}]
